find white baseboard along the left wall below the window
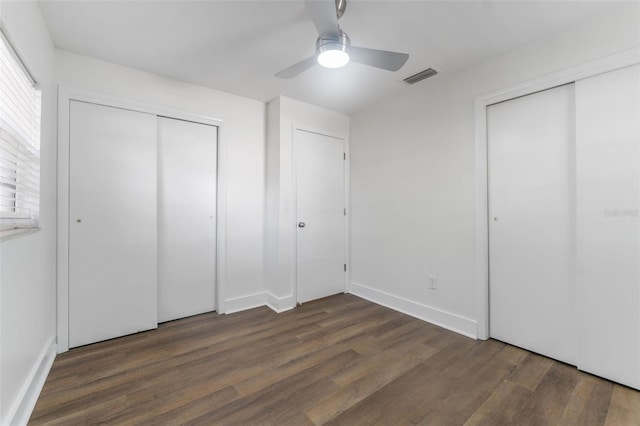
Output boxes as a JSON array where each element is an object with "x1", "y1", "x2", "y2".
[{"x1": 0, "y1": 337, "x2": 58, "y2": 426}]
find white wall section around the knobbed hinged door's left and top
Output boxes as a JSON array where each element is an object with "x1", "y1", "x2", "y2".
[{"x1": 265, "y1": 96, "x2": 349, "y2": 310}]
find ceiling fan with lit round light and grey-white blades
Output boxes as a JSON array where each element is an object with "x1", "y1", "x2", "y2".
[{"x1": 276, "y1": 0, "x2": 409, "y2": 78}]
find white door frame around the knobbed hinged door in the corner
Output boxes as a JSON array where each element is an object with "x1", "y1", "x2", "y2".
[{"x1": 290, "y1": 122, "x2": 351, "y2": 305}]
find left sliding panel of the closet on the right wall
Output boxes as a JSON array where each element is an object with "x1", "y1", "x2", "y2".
[{"x1": 487, "y1": 84, "x2": 577, "y2": 365}]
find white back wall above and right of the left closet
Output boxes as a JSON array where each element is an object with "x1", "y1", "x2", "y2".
[{"x1": 56, "y1": 50, "x2": 265, "y2": 310}]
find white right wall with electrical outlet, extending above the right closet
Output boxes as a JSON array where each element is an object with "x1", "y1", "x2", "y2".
[{"x1": 350, "y1": 3, "x2": 640, "y2": 336}]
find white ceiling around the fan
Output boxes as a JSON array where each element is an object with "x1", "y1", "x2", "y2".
[{"x1": 40, "y1": 0, "x2": 616, "y2": 114}]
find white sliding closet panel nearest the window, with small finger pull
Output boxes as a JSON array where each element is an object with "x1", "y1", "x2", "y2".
[{"x1": 69, "y1": 101, "x2": 158, "y2": 347}]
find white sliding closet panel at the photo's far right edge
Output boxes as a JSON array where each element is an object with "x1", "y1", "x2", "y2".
[{"x1": 576, "y1": 65, "x2": 640, "y2": 389}]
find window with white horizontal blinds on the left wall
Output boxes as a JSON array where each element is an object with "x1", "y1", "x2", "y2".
[{"x1": 0, "y1": 33, "x2": 40, "y2": 231}]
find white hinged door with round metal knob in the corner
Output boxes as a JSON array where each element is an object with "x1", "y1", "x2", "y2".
[{"x1": 294, "y1": 130, "x2": 345, "y2": 303}]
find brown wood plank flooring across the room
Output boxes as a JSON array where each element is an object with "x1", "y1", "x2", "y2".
[{"x1": 30, "y1": 294, "x2": 640, "y2": 426}]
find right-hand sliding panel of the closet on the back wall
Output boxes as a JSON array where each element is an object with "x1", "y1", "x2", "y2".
[{"x1": 158, "y1": 117, "x2": 218, "y2": 322}]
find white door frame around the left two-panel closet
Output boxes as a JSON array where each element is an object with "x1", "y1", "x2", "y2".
[{"x1": 57, "y1": 85, "x2": 227, "y2": 353}]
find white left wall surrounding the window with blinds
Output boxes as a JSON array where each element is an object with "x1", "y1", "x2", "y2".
[{"x1": 0, "y1": 1, "x2": 56, "y2": 425}]
